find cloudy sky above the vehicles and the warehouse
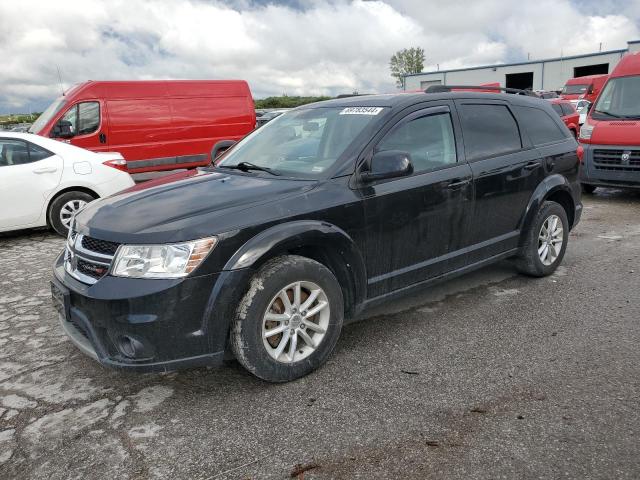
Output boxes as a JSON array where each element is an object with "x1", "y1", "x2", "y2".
[{"x1": 0, "y1": 0, "x2": 640, "y2": 113}]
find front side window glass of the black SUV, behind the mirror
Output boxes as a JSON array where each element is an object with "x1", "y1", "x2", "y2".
[{"x1": 377, "y1": 113, "x2": 457, "y2": 172}]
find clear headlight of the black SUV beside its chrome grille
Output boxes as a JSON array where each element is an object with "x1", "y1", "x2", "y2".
[{"x1": 111, "y1": 237, "x2": 217, "y2": 278}]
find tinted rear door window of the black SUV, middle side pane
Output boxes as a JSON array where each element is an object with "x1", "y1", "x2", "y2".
[{"x1": 460, "y1": 104, "x2": 522, "y2": 160}]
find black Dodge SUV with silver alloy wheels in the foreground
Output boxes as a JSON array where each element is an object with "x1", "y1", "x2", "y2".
[{"x1": 52, "y1": 87, "x2": 582, "y2": 382}]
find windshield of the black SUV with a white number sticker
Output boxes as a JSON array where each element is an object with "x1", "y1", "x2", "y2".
[{"x1": 216, "y1": 107, "x2": 384, "y2": 178}]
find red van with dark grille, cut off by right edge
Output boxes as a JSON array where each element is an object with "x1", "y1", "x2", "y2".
[{"x1": 580, "y1": 52, "x2": 640, "y2": 189}]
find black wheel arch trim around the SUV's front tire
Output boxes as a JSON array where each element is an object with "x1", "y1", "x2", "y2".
[{"x1": 253, "y1": 245, "x2": 358, "y2": 317}]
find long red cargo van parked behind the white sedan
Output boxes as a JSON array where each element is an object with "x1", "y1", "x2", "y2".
[{"x1": 29, "y1": 80, "x2": 256, "y2": 173}]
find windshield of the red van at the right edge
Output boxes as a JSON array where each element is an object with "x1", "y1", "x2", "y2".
[{"x1": 593, "y1": 75, "x2": 640, "y2": 118}]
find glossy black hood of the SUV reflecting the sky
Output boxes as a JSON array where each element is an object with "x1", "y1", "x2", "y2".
[{"x1": 75, "y1": 169, "x2": 317, "y2": 244}]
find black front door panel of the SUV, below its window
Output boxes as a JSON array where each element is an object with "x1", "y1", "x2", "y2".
[{"x1": 365, "y1": 164, "x2": 472, "y2": 296}]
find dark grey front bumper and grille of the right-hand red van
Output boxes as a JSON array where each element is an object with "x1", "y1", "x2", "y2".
[{"x1": 580, "y1": 143, "x2": 640, "y2": 188}]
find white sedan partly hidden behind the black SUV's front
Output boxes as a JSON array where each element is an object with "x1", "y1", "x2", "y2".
[{"x1": 0, "y1": 132, "x2": 134, "y2": 235}]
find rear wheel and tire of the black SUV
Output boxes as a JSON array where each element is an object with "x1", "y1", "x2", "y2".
[{"x1": 515, "y1": 202, "x2": 569, "y2": 277}]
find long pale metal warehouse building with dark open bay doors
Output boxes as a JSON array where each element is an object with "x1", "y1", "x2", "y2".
[{"x1": 404, "y1": 40, "x2": 640, "y2": 90}]
